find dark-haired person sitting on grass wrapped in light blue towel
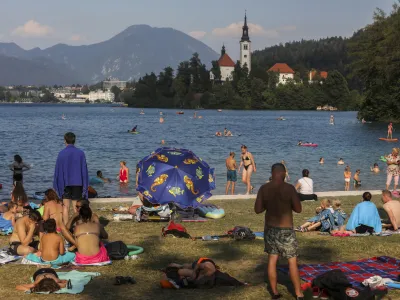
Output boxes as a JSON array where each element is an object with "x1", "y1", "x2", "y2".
[{"x1": 331, "y1": 192, "x2": 382, "y2": 234}]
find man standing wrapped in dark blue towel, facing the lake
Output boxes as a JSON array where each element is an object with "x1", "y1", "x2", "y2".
[{"x1": 53, "y1": 132, "x2": 89, "y2": 223}]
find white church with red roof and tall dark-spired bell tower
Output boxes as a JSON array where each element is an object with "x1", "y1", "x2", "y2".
[{"x1": 210, "y1": 12, "x2": 251, "y2": 82}]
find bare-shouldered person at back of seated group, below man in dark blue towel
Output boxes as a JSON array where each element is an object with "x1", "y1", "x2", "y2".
[{"x1": 40, "y1": 189, "x2": 75, "y2": 245}]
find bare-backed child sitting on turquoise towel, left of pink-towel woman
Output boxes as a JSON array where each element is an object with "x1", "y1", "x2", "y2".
[{"x1": 26, "y1": 219, "x2": 75, "y2": 266}]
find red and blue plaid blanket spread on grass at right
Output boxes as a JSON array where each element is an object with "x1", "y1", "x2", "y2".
[{"x1": 279, "y1": 256, "x2": 400, "y2": 286}]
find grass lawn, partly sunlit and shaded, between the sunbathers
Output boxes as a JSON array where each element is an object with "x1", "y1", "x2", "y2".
[{"x1": 0, "y1": 196, "x2": 400, "y2": 299}]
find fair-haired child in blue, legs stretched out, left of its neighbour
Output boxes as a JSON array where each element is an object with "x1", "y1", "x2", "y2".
[{"x1": 296, "y1": 199, "x2": 335, "y2": 232}]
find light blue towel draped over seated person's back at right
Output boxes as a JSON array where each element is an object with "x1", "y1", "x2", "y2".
[{"x1": 346, "y1": 201, "x2": 382, "y2": 233}]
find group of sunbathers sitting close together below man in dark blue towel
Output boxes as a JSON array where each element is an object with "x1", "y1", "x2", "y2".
[{"x1": 0, "y1": 189, "x2": 109, "y2": 276}]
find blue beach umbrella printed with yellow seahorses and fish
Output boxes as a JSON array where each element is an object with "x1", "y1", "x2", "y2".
[{"x1": 136, "y1": 147, "x2": 215, "y2": 208}]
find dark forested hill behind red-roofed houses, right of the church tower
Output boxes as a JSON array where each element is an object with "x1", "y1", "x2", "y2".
[{"x1": 252, "y1": 34, "x2": 359, "y2": 89}]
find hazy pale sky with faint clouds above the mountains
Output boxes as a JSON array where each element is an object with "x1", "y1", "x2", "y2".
[{"x1": 0, "y1": 0, "x2": 395, "y2": 59}]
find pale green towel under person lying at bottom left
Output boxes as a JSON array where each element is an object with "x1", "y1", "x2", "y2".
[{"x1": 26, "y1": 270, "x2": 101, "y2": 294}]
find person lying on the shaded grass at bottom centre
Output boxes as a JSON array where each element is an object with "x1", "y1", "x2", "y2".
[{"x1": 160, "y1": 258, "x2": 247, "y2": 289}]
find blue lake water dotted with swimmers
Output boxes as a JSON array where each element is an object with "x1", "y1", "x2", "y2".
[{"x1": 0, "y1": 105, "x2": 396, "y2": 199}]
